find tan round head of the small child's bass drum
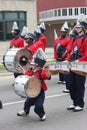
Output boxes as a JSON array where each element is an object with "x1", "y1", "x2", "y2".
[{"x1": 25, "y1": 77, "x2": 41, "y2": 98}]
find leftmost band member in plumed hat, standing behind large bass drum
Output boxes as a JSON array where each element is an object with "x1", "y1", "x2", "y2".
[{"x1": 10, "y1": 22, "x2": 24, "y2": 78}]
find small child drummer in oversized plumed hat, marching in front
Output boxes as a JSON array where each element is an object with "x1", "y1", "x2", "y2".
[{"x1": 17, "y1": 48, "x2": 51, "y2": 121}]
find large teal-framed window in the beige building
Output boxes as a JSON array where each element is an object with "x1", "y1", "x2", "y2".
[{"x1": 0, "y1": 11, "x2": 26, "y2": 40}]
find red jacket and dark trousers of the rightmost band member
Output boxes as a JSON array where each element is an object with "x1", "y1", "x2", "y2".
[{"x1": 67, "y1": 35, "x2": 87, "y2": 108}]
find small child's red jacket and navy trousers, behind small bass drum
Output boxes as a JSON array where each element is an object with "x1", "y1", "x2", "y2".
[{"x1": 24, "y1": 69, "x2": 51, "y2": 118}]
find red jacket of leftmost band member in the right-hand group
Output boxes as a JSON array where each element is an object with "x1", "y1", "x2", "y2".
[{"x1": 54, "y1": 37, "x2": 70, "y2": 59}]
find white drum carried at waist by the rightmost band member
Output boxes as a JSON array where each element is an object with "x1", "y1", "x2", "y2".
[{"x1": 71, "y1": 62, "x2": 87, "y2": 76}]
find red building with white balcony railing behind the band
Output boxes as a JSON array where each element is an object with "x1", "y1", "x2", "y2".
[{"x1": 37, "y1": 0, "x2": 87, "y2": 47}]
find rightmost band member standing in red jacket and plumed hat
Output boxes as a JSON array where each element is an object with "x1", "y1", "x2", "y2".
[{"x1": 67, "y1": 13, "x2": 87, "y2": 112}]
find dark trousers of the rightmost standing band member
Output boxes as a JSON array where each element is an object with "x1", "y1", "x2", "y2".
[{"x1": 70, "y1": 72, "x2": 86, "y2": 107}]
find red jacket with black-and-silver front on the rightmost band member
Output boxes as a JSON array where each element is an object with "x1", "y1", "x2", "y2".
[{"x1": 67, "y1": 35, "x2": 87, "y2": 62}]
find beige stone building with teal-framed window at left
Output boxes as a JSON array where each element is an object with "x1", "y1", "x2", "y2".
[{"x1": 0, "y1": 0, "x2": 37, "y2": 41}]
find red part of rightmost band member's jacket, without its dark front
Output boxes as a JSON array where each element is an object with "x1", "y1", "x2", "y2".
[{"x1": 67, "y1": 36, "x2": 87, "y2": 61}]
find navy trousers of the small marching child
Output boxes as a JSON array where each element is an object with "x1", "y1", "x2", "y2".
[{"x1": 24, "y1": 90, "x2": 45, "y2": 118}]
